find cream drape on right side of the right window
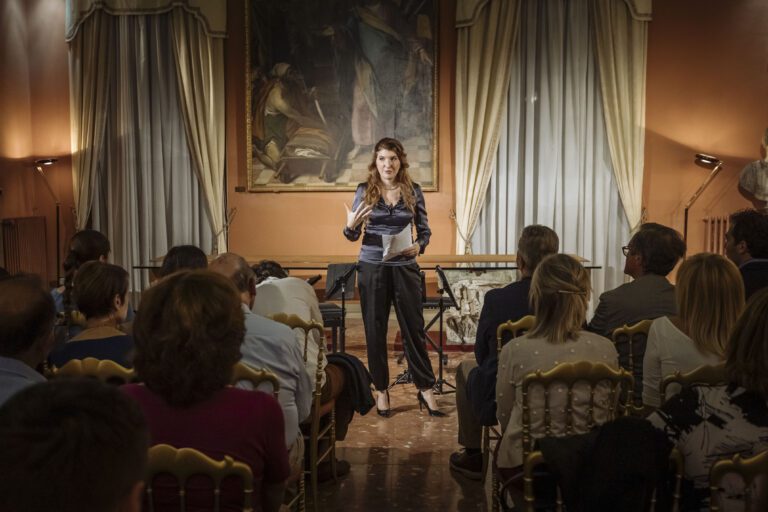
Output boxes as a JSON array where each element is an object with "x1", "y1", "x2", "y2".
[{"x1": 591, "y1": 0, "x2": 650, "y2": 230}]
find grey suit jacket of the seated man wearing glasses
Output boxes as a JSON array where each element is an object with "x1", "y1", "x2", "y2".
[{"x1": 587, "y1": 274, "x2": 677, "y2": 339}]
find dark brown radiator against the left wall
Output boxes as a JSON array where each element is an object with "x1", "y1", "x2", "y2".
[{"x1": 3, "y1": 217, "x2": 49, "y2": 282}]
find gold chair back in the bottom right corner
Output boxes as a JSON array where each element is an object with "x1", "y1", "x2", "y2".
[{"x1": 709, "y1": 450, "x2": 768, "y2": 512}]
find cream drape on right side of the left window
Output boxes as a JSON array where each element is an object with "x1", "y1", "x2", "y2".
[{"x1": 171, "y1": 9, "x2": 227, "y2": 253}]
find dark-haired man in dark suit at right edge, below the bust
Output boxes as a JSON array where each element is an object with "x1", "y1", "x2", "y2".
[{"x1": 725, "y1": 210, "x2": 768, "y2": 299}]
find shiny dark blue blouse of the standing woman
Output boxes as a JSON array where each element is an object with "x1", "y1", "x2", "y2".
[{"x1": 344, "y1": 183, "x2": 432, "y2": 266}]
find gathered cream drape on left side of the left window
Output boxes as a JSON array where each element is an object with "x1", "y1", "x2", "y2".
[{"x1": 69, "y1": 12, "x2": 110, "y2": 226}]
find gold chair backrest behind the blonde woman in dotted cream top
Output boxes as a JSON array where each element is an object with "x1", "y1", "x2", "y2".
[{"x1": 521, "y1": 361, "x2": 632, "y2": 460}]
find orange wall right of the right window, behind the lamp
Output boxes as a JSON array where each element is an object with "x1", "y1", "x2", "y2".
[{"x1": 643, "y1": 0, "x2": 768, "y2": 254}]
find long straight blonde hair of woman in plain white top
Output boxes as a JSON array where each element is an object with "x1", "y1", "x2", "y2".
[{"x1": 675, "y1": 253, "x2": 744, "y2": 358}]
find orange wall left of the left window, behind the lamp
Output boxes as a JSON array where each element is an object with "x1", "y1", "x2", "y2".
[{"x1": 0, "y1": 0, "x2": 74, "y2": 280}]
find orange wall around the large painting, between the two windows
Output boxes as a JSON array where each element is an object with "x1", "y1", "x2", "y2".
[{"x1": 227, "y1": 0, "x2": 456, "y2": 256}]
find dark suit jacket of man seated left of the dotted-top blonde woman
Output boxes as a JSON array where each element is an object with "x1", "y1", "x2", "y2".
[{"x1": 467, "y1": 277, "x2": 532, "y2": 426}]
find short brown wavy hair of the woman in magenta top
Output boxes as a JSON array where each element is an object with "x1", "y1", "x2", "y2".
[{"x1": 133, "y1": 270, "x2": 245, "y2": 407}]
